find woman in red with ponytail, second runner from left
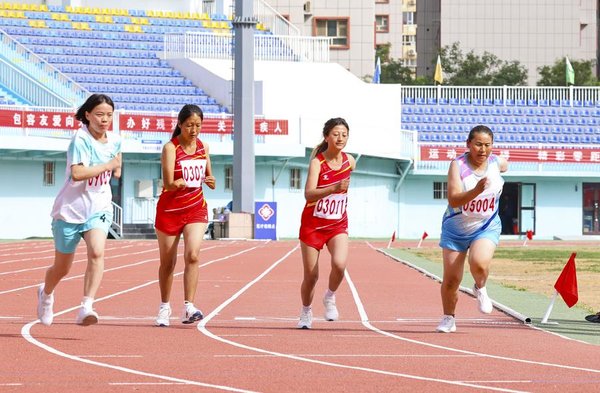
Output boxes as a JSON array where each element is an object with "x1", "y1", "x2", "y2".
[{"x1": 155, "y1": 105, "x2": 215, "y2": 326}]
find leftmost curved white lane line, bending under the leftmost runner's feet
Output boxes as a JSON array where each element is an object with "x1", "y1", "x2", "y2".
[{"x1": 21, "y1": 246, "x2": 258, "y2": 393}]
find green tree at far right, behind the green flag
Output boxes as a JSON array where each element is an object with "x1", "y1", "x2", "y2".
[{"x1": 537, "y1": 57, "x2": 600, "y2": 86}]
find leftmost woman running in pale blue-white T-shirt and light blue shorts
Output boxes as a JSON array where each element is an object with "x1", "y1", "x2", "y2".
[{"x1": 37, "y1": 94, "x2": 121, "y2": 326}]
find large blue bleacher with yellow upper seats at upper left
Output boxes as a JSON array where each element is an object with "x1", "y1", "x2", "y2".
[{"x1": 0, "y1": 3, "x2": 239, "y2": 113}]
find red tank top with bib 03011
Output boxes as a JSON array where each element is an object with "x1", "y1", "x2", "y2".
[{"x1": 302, "y1": 152, "x2": 352, "y2": 229}]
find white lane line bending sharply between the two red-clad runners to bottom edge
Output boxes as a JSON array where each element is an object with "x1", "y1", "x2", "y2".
[{"x1": 198, "y1": 245, "x2": 520, "y2": 392}]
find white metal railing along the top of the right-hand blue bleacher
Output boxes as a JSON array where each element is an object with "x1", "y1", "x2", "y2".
[{"x1": 402, "y1": 85, "x2": 600, "y2": 106}]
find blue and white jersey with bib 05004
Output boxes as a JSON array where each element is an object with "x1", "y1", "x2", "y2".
[{"x1": 442, "y1": 153, "x2": 504, "y2": 236}]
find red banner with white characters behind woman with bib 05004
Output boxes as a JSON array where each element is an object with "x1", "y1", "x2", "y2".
[{"x1": 421, "y1": 146, "x2": 600, "y2": 164}]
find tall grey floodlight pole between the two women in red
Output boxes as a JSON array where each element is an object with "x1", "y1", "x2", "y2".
[{"x1": 232, "y1": 1, "x2": 256, "y2": 213}]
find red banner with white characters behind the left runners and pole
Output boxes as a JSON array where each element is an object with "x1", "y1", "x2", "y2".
[{"x1": 0, "y1": 109, "x2": 288, "y2": 135}]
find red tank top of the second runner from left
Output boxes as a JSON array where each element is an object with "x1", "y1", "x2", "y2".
[{"x1": 157, "y1": 137, "x2": 207, "y2": 213}]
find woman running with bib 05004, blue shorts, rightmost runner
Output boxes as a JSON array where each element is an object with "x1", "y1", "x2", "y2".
[{"x1": 437, "y1": 125, "x2": 508, "y2": 333}]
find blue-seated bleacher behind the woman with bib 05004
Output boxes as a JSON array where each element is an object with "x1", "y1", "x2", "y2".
[{"x1": 402, "y1": 97, "x2": 600, "y2": 144}]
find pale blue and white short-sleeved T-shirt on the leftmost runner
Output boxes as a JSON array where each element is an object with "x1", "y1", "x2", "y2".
[{"x1": 50, "y1": 125, "x2": 121, "y2": 224}]
